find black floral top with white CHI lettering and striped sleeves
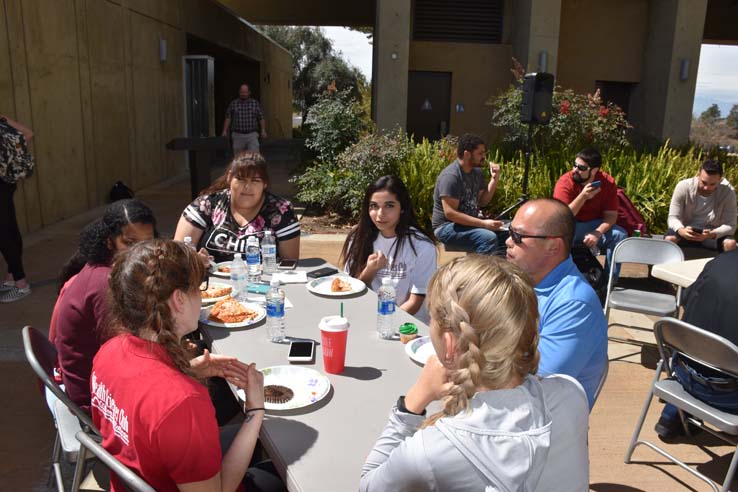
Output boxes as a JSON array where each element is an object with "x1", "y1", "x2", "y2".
[{"x1": 182, "y1": 189, "x2": 300, "y2": 262}]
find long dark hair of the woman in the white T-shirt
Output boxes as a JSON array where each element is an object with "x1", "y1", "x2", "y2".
[{"x1": 339, "y1": 176, "x2": 435, "y2": 277}]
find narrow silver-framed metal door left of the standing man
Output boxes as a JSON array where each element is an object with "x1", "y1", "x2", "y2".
[{"x1": 182, "y1": 56, "x2": 215, "y2": 137}]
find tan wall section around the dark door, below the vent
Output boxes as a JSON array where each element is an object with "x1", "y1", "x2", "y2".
[{"x1": 410, "y1": 41, "x2": 512, "y2": 141}]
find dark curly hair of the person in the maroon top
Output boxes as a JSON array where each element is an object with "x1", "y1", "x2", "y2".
[{"x1": 59, "y1": 198, "x2": 158, "y2": 289}]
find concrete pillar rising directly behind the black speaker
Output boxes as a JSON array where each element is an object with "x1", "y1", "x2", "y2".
[{"x1": 505, "y1": 0, "x2": 561, "y2": 75}]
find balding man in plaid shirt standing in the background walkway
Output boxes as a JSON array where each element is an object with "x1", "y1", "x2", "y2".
[{"x1": 223, "y1": 84, "x2": 267, "y2": 155}]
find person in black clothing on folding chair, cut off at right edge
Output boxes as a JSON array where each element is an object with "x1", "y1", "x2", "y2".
[{"x1": 655, "y1": 250, "x2": 738, "y2": 439}]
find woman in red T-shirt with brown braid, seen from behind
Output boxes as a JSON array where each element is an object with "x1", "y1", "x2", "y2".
[{"x1": 91, "y1": 239, "x2": 282, "y2": 492}]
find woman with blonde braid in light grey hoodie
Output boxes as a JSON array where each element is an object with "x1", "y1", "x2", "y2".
[{"x1": 360, "y1": 255, "x2": 589, "y2": 492}]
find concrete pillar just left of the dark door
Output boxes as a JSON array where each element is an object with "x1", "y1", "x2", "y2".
[{"x1": 372, "y1": 0, "x2": 411, "y2": 130}]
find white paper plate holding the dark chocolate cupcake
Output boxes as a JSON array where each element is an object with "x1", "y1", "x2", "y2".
[{"x1": 238, "y1": 366, "x2": 331, "y2": 410}]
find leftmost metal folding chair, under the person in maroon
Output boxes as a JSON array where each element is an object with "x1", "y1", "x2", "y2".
[{"x1": 23, "y1": 326, "x2": 100, "y2": 492}]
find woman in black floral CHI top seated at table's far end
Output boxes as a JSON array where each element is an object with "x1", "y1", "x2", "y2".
[{"x1": 174, "y1": 152, "x2": 300, "y2": 262}]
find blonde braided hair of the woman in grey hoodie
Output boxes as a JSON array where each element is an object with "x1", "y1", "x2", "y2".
[{"x1": 423, "y1": 255, "x2": 539, "y2": 427}]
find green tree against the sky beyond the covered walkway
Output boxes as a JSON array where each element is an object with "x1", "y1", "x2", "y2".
[{"x1": 262, "y1": 26, "x2": 367, "y2": 121}]
